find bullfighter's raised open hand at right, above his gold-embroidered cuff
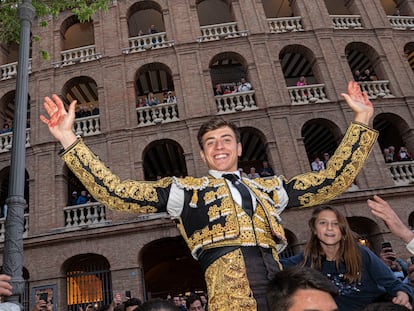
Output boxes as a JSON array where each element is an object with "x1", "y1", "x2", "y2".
[{"x1": 341, "y1": 81, "x2": 374, "y2": 125}]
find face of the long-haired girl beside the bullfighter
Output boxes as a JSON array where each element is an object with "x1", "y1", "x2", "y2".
[{"x1": 315, "y1": 210, "x2": 342, "y2": 249}]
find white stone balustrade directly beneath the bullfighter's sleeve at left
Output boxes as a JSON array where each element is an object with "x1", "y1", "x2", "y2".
[{"x1": 63, "y1": 202, "x2": 106, "y2": 228}]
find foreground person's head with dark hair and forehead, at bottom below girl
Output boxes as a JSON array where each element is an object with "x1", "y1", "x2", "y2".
[{"x1": 267, "y1": 266, "x2": 338, "y2": 311}]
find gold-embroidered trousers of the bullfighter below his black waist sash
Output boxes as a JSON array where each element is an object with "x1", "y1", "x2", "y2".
[{"x1": 205, "y1": 249, "x2": 256, "y2": 311}]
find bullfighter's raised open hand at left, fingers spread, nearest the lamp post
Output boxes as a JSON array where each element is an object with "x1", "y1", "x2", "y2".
[{"x1": 40, "y1": 94, "x2": 76, "y2": 148}]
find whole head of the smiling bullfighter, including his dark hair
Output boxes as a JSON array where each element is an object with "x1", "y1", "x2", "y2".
[{"x1": 197, "y1": 118, "x2": 242, "y2": 172}]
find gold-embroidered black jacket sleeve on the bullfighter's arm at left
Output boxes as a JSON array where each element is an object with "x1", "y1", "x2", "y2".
[{"x1": 61, "y1": 139, "x2": 172, "y2": 213}]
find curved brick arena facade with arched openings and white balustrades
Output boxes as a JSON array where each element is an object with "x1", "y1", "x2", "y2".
[{"x1": 0, "y1": 0, "x2": 414, "y2": 310}]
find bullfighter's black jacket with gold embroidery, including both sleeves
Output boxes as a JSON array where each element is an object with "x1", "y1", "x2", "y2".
[{"x1": 62, "y1": 122, "x2": 378, "y2": 260}]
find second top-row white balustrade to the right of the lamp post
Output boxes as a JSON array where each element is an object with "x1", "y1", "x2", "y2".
[{"x1": 122, "y1": 32, "x2": 174, "y2": 54}]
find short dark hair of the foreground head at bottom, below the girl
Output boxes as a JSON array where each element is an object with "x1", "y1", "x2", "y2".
[{"x1": 266, "y1": 266, "x2": 338, "y2": 311}]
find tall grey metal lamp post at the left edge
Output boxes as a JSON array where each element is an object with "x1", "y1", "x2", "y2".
[{"x1": 3, "y1": 0, "x2": 35, "y2": 307}]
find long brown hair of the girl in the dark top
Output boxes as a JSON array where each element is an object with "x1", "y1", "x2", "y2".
[{"x1": 302, "y1": 206, "x2": 362, "y2": 283}]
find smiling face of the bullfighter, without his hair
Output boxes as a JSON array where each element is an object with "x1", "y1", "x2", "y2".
[{"x1": 200, "y1": 126, "x2": 242, "y2": 172}]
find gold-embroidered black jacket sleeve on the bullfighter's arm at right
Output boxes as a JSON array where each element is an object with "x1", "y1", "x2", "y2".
[{"x1": 285, "y1": 122, "x2": 378, "y2": 207}]
